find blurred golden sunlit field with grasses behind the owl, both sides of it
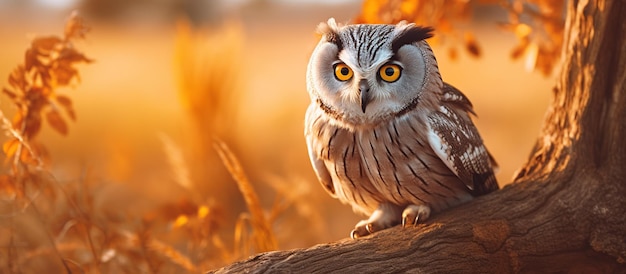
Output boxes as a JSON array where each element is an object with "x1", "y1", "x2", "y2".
[{"x1": 0, "y1": 1, "x2": 554, "y2": 273}]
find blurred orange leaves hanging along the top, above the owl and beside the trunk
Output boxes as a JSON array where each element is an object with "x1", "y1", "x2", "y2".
[{"x1": 356, "y1": 0, "x2": 565, "y2": 76}]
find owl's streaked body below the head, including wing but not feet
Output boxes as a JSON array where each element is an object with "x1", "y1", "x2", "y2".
[{"x1": 305, "y1": 84, "x2": 498, "y2": 214}]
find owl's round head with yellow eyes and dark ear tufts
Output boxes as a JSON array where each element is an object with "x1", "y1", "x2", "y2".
[{"x1": 307, "y1": 18, "x2": 442, "y2": 127}]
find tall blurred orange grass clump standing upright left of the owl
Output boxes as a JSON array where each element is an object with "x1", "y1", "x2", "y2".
[{"x1": 174, "y1": 17, "x2": 245, "y2": 211}]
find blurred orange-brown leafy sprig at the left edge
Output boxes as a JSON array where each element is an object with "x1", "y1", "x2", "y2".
[{"x1": 0, "y1": 10, "x2": 92, "y2": 176}]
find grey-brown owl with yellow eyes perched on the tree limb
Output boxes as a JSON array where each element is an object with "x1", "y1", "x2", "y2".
[{"x1": 304, "y1": 18, "x2": 498, "y2": 238}]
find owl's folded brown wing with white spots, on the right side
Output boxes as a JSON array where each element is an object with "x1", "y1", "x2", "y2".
[{"x1": 428, "y1": 83, "x2": 498, "y2": 196}]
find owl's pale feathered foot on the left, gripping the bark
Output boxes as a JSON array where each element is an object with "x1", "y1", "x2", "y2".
[{"x1": 350, "y1": 203, "x2": 402, "y2": 239}]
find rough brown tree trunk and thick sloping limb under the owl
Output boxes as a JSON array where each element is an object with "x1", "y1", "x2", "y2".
[{"x1": 215, "y1": 0, "x2": 626, "y2": 273}]
